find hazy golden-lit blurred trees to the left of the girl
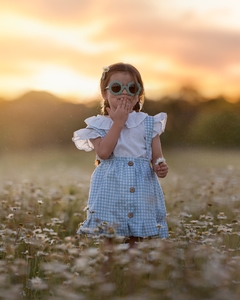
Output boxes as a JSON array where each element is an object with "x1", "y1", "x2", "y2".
[{"x1": 0, "y1": 92, "x2": 98, "y2": 151}]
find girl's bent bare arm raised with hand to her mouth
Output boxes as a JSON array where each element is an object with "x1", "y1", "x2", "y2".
[{"x1": 91, "y1": 100, "x2": 131, "y2": 159}]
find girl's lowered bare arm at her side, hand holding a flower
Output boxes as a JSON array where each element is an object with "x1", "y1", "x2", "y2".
[{"x1": 152, "y1": 135, "x2": 168, "y2": 178}]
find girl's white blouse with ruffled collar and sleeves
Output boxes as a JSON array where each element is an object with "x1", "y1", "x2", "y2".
[{"x1": 72, "y1": 111, "x2": 167, "y2": 157}]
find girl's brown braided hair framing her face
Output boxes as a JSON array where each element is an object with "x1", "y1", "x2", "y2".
[{"x1": 100, "y1": 63, "x2": 144, "y2": 115}]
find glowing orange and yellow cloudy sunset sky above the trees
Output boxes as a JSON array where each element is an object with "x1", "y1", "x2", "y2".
[{"x1": 0, "y1": 0, "x2": 240, "y2": 102}]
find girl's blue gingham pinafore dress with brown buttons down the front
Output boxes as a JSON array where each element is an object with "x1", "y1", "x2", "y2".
[{"x1": 73, "y1": 116, "x2": 168, "y2": 238}]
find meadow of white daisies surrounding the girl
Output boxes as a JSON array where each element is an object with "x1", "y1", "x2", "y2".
[{"x1": 0, "y1": 147, "x2": 240, "y2": 300}]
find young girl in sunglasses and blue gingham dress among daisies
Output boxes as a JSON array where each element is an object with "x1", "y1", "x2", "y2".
[{"x1": 73, "y1": 63, "x2": 168, "y2": 244}]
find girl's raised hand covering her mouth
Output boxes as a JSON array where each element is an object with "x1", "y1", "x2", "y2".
[{"x1": 106, "y1": 98, "x2": 132, "y2": 126}]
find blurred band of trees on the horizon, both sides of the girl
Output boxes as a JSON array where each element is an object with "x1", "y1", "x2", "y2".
[{"x1": 0, "y1": 90, "x2": 240, "y2": 151}]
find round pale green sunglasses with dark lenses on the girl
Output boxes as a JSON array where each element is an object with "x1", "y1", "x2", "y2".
[{"x1": 105, "y1": 80, "x2": 142, "y2": 96}]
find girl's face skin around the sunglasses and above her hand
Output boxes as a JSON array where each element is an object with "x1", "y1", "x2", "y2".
[{"x1": 104, "y1": 72, "x2": 139, "y2": 110}]
